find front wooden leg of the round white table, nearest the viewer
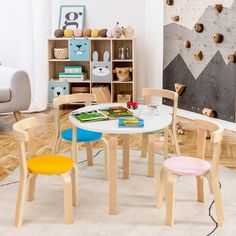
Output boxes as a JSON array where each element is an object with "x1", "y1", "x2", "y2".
[{"x1": 108, "y1": 135, "x2": 117, "y2": 215}]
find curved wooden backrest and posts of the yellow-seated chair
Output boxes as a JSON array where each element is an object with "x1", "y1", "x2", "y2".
[{"x1": 13, "y1": 117, "x2": 39, "y2": 171}]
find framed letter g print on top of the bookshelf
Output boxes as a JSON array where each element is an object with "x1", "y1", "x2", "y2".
[{"x1": 58, "y1": 5, "x2": 85, "y2": 30}]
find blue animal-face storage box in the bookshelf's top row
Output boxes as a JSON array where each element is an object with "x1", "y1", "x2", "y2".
[{"x1": 69, "y1": 38, "x2": 90, "y2": 61}]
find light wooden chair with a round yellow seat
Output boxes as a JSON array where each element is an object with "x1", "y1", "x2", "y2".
[{"x1": 13, "y1": 117, "x2": 74, "y2": 227}]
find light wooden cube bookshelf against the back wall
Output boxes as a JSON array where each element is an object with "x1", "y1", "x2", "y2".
[{"x1": 48, "y1": 38, "x2": 136, "y2": 103}]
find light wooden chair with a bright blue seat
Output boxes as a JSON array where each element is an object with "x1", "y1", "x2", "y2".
[{"x1": 53, "y1": 93, "x2": 108, "y2": 179}]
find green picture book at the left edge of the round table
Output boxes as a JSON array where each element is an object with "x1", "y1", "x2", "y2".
[{"x1": 72, "y1": 110, "x2": 108, "y2": 122}]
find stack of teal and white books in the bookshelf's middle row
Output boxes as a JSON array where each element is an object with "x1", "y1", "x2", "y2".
[{"x1": 59, "y1": 66, "x2": 87, "y2": 83}]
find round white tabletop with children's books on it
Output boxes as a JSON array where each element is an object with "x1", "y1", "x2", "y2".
[{"x1": 69, "y1": 103, "x2": 172, "y2": 134}]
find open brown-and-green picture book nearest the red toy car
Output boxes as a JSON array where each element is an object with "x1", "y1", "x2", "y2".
[{"x1": 99, "y1": 106, "x2": 134, "y2": 119}]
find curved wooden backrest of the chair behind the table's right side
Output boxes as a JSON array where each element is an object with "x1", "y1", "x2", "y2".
[{"x1": 142, "y1": 88, "x2": 179, "y2": 129}]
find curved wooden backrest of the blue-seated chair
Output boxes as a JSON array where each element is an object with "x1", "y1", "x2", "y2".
[{"x1": 53, "y1": 93, "x2": 97, "y2": 136}]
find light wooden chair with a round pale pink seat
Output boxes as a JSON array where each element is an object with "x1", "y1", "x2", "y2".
[{"x1": 157, "y1": 120, "x2": 224, "y2": 226}]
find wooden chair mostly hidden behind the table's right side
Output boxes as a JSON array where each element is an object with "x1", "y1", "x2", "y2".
[{"x1": 141, "y1": 88, "x2": 180, "y2": 177}]
